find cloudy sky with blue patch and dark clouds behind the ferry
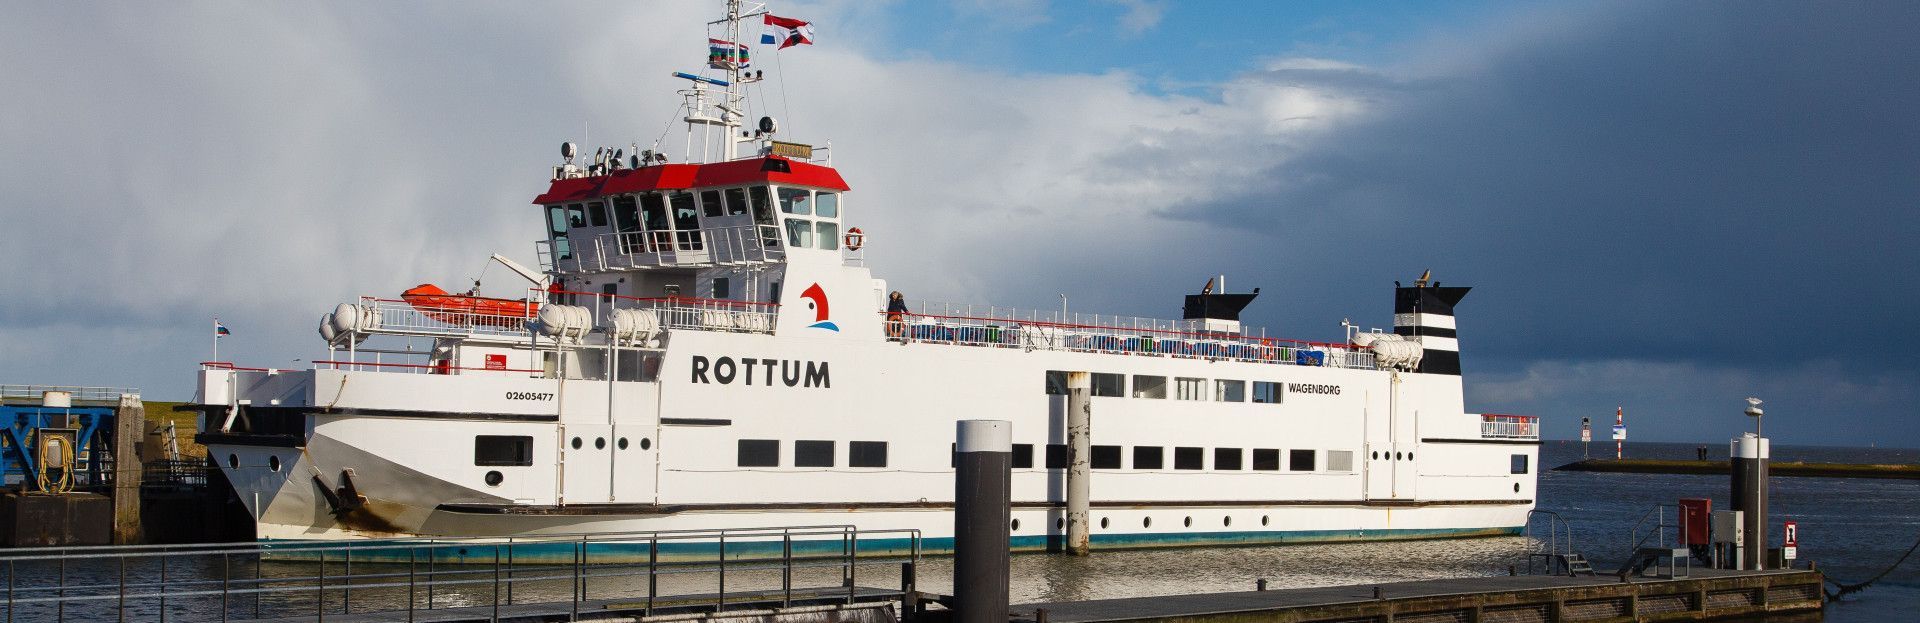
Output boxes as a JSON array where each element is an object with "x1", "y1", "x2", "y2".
[{"x1": 0, "y1": 0, "x2": 1920, "y2": 446}]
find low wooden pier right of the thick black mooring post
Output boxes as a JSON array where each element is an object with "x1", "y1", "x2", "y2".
[{"x1": 1014, "y1": 569, "x2": 1824, "y2": 623}]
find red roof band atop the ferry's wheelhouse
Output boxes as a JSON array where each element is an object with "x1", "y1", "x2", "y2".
[{"x1": 534, "y1": 156, "x2": 849, "y2": 204}]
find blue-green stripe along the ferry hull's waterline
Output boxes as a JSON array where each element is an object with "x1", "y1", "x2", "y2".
[{"x1": 261, "y1": 527, "x2": 1521, "y2": 565}]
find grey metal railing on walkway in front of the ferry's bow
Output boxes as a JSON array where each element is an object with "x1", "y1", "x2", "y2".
[{"x1": 0, "y1": 525, "x2": 922, "y2": 621}]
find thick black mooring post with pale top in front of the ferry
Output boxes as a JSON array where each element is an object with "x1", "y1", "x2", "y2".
[{"x1": 954, "y1": 419, "x2": 1014, "y2": 623}]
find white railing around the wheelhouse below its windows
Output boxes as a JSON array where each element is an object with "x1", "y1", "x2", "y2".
[{"x1": 534, "y1": 225, "x2": 787, "y2": 273}]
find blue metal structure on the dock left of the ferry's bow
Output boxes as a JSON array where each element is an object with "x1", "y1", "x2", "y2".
[{"x1": 0, "y1": 406, "x2": 113, "y2": 490}]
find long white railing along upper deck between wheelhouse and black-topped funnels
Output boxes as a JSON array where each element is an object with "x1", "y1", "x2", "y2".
[{"x1": 885, "y1": 304, "x2": 1375, "y2": 369}]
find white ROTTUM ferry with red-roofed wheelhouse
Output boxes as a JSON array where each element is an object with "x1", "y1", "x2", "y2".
[{"x1": 192, "y1": 2, "x2": 1538, "y2": 550}]
